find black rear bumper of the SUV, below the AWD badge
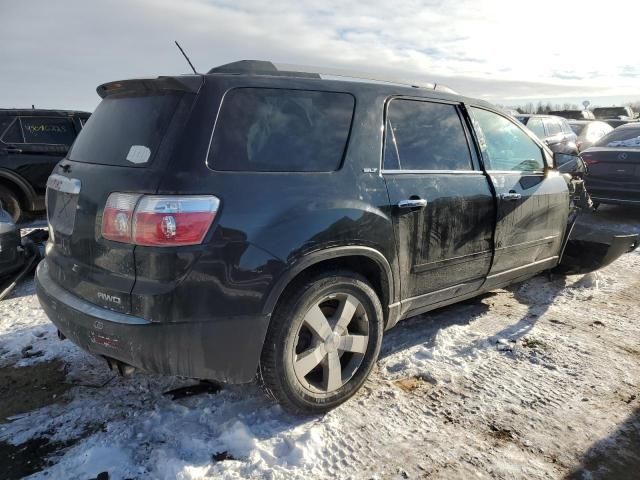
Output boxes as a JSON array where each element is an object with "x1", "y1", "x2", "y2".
[{"x1": 35, "y1": 259, "x2": 269, "y2": 383}]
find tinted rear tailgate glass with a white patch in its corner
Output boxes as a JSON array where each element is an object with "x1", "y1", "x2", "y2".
[{"x1": 69, "y1": 95, "x2": 180, "y2": 167}]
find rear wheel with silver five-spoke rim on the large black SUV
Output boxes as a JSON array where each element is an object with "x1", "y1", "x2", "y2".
[{"x1": 259, "y1": 271, "x2": 384, "y2": 414}]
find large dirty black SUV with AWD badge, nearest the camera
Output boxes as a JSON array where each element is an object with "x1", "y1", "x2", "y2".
[{"x1": 36, "y1": 62, "x2": 592, "y2": 411}]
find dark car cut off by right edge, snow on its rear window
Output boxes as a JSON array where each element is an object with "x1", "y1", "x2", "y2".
[{"x1": 582, "y1": 123, "x2": 640, "y2": 206}]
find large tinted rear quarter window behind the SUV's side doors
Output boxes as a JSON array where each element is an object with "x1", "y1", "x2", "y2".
[{"x1": 208, "y1": 88, "x2": 355, "y2": 172}]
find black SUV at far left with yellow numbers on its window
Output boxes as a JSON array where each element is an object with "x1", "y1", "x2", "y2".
[{"x1": 0, "y1": 109, "x2": 90, "y2": 221}]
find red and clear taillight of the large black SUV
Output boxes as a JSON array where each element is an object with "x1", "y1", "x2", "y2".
[{"x1": 102, "y1": 193, "x2": 220, "y2": 247}]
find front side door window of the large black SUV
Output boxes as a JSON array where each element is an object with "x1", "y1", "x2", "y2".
[{"x1": 471, "y1": 108, "x2": 544, "y2": 172}]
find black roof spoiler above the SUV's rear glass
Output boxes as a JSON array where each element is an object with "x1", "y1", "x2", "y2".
[{"x1": 96, "y1": 75, "x2": 204, "y2": 98}]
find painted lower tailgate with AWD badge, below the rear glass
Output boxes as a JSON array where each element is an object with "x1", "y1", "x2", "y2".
[{"x1": 47, "y1": 160, "x2": 160, "y2": 313}]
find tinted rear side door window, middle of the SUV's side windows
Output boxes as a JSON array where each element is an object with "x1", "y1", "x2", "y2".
[{"x1": 384, "y1": 99, "x2": 471, "y2": 170}]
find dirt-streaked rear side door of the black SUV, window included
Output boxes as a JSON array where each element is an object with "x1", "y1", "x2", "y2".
[{"x1": 382, "y1": 98, "x2": 495, "y2": 313}]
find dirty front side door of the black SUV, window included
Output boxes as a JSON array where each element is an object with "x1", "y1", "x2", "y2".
[{"x1": 470, "y1": 107, "x2": 569, "y2": 288}]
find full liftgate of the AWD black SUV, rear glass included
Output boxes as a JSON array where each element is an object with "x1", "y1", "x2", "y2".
[{"x1": 47, "y1": 81, "x2": 193, "y2": 313}]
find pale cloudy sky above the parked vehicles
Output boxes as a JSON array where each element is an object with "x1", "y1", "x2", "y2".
[{"x1": 0, "y1": 0, "x2": 640, "y2": 110}]
